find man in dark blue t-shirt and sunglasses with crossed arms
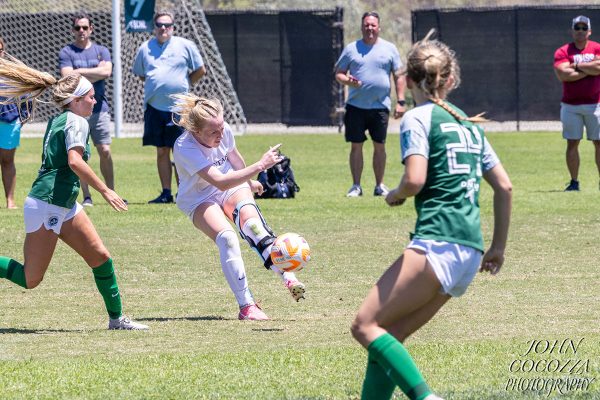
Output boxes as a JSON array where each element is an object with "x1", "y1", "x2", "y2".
[{"x1": 58, "y1": 14, "x2": 115, "y2": 207}]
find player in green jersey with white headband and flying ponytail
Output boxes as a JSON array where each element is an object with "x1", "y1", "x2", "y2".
[{"x1": 0, "y1": 58, "x2": 148, "y2": 330}]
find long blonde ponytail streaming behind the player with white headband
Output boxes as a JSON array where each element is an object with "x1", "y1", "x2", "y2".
[{"x1": 0, "y1": 55, "x2": 81, "y2": 119}]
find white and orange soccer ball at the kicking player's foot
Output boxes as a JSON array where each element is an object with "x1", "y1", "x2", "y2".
[{"x1": 271, "y1": 233, "x2": 310, "y2": 272}]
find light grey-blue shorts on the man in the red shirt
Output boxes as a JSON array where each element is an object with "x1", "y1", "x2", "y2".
[{"x1": 560, "y1": 103, "x2": 600, "y2": 140}]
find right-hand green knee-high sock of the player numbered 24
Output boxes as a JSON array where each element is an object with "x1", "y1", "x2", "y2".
[{"x1": 368, "y1": 333, "x2": 432, "y2": 400}]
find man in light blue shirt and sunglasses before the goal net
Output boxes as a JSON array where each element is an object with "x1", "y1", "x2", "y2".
[{"x1": 133, "y1": 12, "x2": 206, "y2": 204}]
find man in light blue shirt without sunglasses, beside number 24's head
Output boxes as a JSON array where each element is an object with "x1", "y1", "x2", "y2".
[{"x1": 335, "y1": 12, "x2": 406, "y2": 197}]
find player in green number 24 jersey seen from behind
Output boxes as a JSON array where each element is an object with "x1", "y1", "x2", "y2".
[{"x1": 352, "y1": 32, "x2": 512, "y2": 400}]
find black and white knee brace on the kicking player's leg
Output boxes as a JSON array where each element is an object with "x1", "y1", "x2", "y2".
[{"x1": 233, "y1": 199, "x2": 276, "y2": 269}]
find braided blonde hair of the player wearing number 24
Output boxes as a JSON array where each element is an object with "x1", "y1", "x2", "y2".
[{"x1": 406, "y1": 29, "x2": 488, "y2": 122}]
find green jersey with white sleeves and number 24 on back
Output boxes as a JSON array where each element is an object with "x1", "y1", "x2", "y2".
[{"x1": 400, "y1": 102, "x2": 500, "y2": 251}]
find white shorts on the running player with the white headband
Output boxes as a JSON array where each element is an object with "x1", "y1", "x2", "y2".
[{"x1": 23, "y1": 196, "x2": 83, "y2": 235}]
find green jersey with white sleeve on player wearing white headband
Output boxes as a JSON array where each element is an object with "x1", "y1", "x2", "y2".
[{"x1": 29, "y1": 111, "x2": 90, "y2": 208}]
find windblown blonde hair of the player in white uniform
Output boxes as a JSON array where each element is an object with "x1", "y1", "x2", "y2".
[{"x1": 172, "y1": 93, "x2": 223, "y2": 132}]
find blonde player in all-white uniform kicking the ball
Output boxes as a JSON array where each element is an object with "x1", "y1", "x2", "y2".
[{"x1": 173, "y1": 94, "x2": 305, "y2": 320}]
